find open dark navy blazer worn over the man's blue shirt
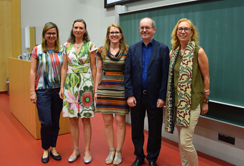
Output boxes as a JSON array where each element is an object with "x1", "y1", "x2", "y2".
[{"x1": 124, "y1": 40, "x2": 169, "y2": 108}]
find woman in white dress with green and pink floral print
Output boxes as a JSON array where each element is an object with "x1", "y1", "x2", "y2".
[{"x1": 59, "y1": 19, "x2": 96, "y2": 163}]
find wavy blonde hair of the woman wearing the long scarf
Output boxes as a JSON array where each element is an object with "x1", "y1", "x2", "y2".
[{"x1": 171, "y1": 18, "x2": 199, "y2": 49}]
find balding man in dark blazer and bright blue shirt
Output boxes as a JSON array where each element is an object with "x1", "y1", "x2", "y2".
[{"x1": 125, "y1": 18, "x2": 169, "y2": 166}]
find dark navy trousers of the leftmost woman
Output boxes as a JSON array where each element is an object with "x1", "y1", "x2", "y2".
[{"x1": 36, "y1": 88, "x2": 63, "y2": 149}]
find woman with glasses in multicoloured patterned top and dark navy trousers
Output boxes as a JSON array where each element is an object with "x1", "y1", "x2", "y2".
[{"x1": 30, "y1": 22, "x2": 63, "y2": 163}]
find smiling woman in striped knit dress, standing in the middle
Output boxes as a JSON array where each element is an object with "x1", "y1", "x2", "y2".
[{"x1": 94, "y1": 24, "x2": 128, "y2": 165}]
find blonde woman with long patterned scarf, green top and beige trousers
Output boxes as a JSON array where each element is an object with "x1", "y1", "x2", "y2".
[{"x1": 165, "y1": 18, "x2": 210, "y2": 166}]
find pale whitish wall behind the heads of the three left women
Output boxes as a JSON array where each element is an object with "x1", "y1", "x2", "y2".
[{"x1": 21, "y1": 0, "x2": 115, "y2": 53}]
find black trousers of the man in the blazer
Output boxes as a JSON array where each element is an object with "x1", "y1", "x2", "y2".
[{"x1": 131, "y1": 94, "x2": 163, "y2": 161}]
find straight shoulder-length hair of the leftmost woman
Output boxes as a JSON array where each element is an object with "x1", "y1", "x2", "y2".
[{"x1": 41, "y1": 22, "x2": 60, "y2": 53}]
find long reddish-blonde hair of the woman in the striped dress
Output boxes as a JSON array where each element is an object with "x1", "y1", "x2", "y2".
[{"x1": 102, "y1": 23, "x2": 128, "y2": 59}]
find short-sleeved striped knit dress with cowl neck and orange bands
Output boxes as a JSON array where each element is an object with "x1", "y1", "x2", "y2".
[{"x1": 95, "y1": 47, "x2": 128, "y2": 115}]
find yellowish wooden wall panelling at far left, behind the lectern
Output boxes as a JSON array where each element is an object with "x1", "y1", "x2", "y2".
[{"x1": 0, "y1": 0, "x2": 21, "y2": 92}]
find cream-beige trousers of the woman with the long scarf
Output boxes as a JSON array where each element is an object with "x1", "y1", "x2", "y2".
[{"x1": 176, "y1": 104, "x2": 201, "y2": 166}]
